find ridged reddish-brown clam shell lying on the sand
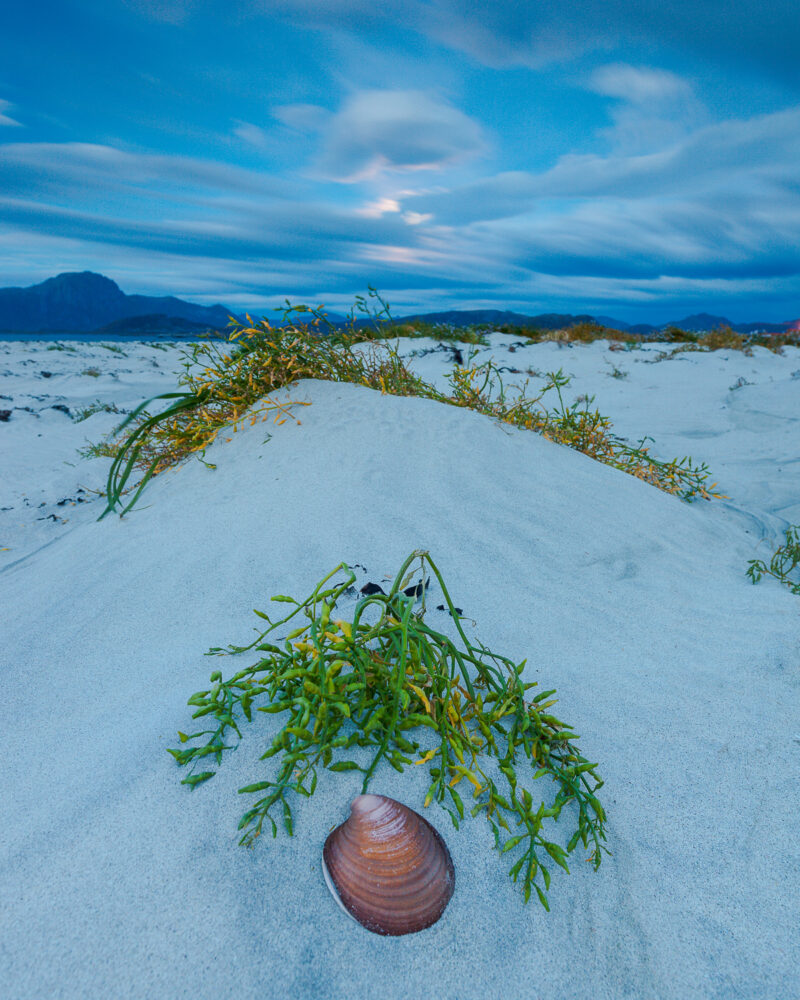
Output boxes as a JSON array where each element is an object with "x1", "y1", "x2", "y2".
[{"x1": 322, "y1": 795, "x2": 455, "y2": 935}]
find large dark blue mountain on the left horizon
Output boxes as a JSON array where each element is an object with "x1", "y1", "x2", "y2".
[{"x1": 0, "y1": 271, "x2": 236, "y2": 333}]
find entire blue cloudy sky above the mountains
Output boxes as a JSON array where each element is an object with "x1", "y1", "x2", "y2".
[{"x1": 0, "y1": 0, "x2": 800, "y2": 323}]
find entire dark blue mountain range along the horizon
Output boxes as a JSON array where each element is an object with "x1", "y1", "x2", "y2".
[{"x1": 0, "y1": 271, "x2": 800, "y2": 337}]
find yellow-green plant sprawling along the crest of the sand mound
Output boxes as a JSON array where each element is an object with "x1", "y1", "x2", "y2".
[{"x1": 101, "y1": 289, "x2": 720, "y2": 516}]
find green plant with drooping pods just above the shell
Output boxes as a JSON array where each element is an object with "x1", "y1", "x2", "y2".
[{"x1": 168, "y1": 550, "x2": 606, "y2": 909}]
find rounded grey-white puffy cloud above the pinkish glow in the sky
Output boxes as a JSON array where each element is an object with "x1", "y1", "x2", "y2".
[{"x1": 318, "y1": 90, "x2": 487, "y2": 183}]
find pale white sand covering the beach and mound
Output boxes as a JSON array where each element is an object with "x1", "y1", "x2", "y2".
[{"x1": 0, "y1": 335, "x2": 800, "y2": 1000}]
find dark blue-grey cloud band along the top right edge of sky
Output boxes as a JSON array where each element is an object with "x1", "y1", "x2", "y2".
[{"x1": 264, "y1": 0, "x2": 800, "y2": 84}]
